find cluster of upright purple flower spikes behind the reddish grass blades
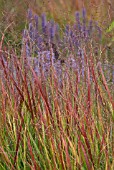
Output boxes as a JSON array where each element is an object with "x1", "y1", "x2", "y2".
[{"x1": 22, "y1": 9, "x2": 101, "y2": 79}]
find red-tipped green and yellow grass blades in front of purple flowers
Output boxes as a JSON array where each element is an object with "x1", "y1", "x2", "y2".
[{"x1": 0, "y1": 36, "x2": 114, "y2": 170}]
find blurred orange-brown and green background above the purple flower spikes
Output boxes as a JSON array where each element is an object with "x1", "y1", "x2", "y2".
[{"x1": 0, "y1": 0, "x2": 114, "y2": 45}]
